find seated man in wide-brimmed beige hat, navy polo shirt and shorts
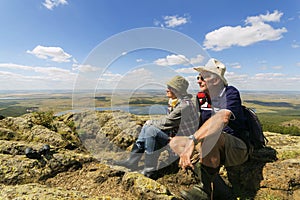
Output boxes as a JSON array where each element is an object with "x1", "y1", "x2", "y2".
[{"x1": 170, "y1": 59, "x2": 248, "y2": 199}]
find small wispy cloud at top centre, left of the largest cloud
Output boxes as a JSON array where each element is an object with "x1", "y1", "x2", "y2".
[{"x1": 154, "y1": 15, "x2": 189, "y2": 28}]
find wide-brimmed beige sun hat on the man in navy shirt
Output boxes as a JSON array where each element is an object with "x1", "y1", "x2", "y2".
[{"x1": 194, "y1": 58, "x2": 228, "y2": 86}]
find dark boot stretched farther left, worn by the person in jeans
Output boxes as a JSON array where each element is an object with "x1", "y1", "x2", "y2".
[{"x1": 113, "y1": 143, "x2": 145, "y2": 170}]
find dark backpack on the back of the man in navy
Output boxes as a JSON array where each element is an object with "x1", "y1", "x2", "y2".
[{"x1": 242, "y1": 106, "x2": 268, "y2": 149}]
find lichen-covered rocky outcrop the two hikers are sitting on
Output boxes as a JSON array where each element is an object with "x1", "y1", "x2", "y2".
[{"x1": 0, "y1": 111, "x2": 300, "y2": 199}]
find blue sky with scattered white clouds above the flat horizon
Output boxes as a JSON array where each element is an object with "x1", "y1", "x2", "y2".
[{"x1": 0, "y1": 0, "x2": 300, "y2": 91}]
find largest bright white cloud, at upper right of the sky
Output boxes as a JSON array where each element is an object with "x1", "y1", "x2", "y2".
[{"x1": 203, "y1": 10, "x2": 287, "y2": 51}]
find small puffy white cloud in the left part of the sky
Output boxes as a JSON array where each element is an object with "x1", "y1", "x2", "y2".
[{"x1": 26, "y1": 45, "x2": 72, "y2": 63}]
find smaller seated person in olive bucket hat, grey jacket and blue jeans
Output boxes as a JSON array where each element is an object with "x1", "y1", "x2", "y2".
[{"x1": 115, "y1": 76, "x2": 199, "y2": 179}]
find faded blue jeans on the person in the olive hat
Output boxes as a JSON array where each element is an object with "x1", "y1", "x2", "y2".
[{"x1": 136, "y1": 125, "x2": 169, "y2": 154}]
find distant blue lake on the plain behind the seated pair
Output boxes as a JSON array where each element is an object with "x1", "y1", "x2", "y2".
[{"x1": 56, "y1": 105, "x2": 168, "y2": 116}]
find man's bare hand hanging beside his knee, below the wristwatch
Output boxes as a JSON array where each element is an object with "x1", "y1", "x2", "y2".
[{"x1": 179, "y1": 140, "x2": 195, "y2": 170}]
